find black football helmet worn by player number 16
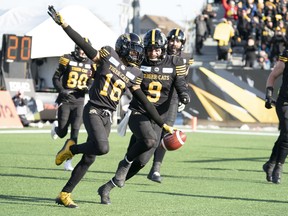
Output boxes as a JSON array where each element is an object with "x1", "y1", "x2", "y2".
[{"x1": 115, "y1": 33, "x2": 144, "y2": 66}]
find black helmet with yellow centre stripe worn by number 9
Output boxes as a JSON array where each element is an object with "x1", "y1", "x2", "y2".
[{"x1": 143, "y1": 29, "x2": 167, "y2": 64}]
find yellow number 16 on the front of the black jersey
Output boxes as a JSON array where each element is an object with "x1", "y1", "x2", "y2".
[{"x1": 100, "y1": 74, "x2": 126, "y2": 101}]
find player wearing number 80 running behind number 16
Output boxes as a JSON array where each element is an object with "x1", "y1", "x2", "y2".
[{"x1": 51, "y1": 38, "x2": 96, "y2": 171}]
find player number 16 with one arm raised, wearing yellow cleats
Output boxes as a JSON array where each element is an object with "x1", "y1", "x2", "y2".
[{"x1": 48, "y1": 6, "x2": 174, "y2": 208}]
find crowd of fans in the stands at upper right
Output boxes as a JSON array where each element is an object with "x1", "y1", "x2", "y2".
[{"x1": 195, "y1": 0, "x2": 288, "y2": 70}]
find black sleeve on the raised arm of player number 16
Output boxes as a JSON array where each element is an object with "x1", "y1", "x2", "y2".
[{"x1": 63, "y1": 25, "x2": 98, "y2": 59}]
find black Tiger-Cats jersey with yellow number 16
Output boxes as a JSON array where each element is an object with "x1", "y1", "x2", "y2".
[{"x1": 89, "y1": 46, "x2": 143, "y2": 111}]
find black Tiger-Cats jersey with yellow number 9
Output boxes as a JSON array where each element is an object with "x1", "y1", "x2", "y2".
[{"x1": 130, "y1": 55, "x2": 187, "y2": 115}]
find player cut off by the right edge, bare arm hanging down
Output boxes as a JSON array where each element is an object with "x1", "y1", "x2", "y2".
[{"x1": 263, "y1": 49, "x2": 288, "y2": 184}]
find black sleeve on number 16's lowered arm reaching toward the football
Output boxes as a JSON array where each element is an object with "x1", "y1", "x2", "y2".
[{"x1": 132, "y1": 89, "x2": 164, "y2": 128}]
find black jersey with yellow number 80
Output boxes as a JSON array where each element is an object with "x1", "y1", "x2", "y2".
[{"x1": 53, "y1": 53, "x2": 96, "y2": 104}]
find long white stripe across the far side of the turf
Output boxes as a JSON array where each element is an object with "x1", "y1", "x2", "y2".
[{"x1": 0, "y1": 128, "x2": 279, "y2": 136}]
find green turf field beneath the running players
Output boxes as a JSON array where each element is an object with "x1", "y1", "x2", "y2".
[{"x1": 0, "y1": 129, "x2": 288, "y2": 216}]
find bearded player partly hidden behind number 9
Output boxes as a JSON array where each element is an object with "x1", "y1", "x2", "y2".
[{"x1": 147, "y1": 28, "x2": 194, "y2": 183}]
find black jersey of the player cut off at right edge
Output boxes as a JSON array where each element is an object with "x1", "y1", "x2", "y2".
[{"x1": 279, "y1": 50, "x2": 288, "y2": 100}]
